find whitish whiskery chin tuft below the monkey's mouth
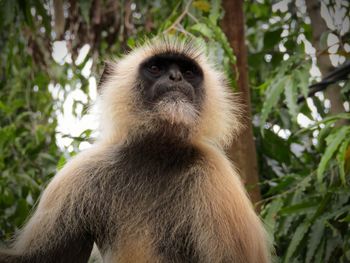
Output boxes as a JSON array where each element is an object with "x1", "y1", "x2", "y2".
[{"x1": 156, "y1": 96, "x2": 198, "y2": 127}]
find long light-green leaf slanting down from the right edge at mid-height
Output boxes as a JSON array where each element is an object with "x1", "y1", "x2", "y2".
[{"x1": 317, "y1": 126, "x2": 350, "y2": 182}]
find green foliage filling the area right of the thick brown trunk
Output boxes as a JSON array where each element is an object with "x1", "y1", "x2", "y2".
[{"x1": 245, "y1": 1, "x2": 350, "y2": 262}]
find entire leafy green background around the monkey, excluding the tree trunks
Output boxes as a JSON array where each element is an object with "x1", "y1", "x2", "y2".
[{"x1": 0, "y1": 0, "x2": 350, "y2": 262}]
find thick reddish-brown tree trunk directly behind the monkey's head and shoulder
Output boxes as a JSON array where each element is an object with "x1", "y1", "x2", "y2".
[{"x1": 222, "y1": 0, "x2": 261, "y2": 210}]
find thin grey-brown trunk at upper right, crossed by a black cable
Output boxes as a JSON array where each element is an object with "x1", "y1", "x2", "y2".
[{"x1": 305, "y1": 0, "x2": 345, "y2": 125}]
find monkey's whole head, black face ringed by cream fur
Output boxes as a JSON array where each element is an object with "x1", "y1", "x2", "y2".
[{"x1": 99, "y1": 39, "x2": 240, "y2": 145}]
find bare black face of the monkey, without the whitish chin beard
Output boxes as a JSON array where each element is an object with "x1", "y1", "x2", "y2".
[{"x1": 139, "y1": 53, "x2": 204, "y2": 106}]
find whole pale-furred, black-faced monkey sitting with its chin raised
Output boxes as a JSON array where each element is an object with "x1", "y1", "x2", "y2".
[{"x1": 0, "y1": 37, "x2": 271, "y2": 263}]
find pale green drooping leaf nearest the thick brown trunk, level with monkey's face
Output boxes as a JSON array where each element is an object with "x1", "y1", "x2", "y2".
[{"x1": 260, "y1": 77, "x2": 287, "y2": 132}]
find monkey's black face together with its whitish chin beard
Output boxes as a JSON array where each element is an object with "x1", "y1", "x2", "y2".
[{"x1": 137, "y1": 52, "x2": 204, "y2": 128}]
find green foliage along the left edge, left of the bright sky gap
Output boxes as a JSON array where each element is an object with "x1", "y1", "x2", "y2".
[{"x1": 0, "y1": 1, "x2": 60, "y2": 239}]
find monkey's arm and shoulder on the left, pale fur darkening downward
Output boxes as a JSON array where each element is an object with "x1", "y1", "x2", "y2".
[{"x1": 0, "y1": 148, "x2": 104, "y2": 263}]
